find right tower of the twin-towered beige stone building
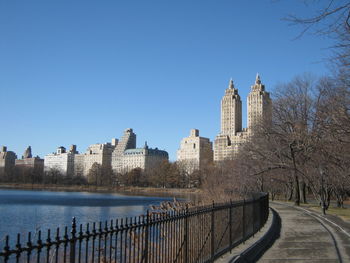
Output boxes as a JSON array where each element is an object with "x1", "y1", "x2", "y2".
[{"x1": 247, "y1": 74, "x2": 272, "y2": 134}]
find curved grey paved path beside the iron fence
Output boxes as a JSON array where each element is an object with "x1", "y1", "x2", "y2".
[{"x1": 258, "y1": 202, "x2": 350, "y2": 263}]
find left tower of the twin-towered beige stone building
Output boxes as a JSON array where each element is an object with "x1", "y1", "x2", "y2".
[{"x1": 221, "y1": 79, "x2": 242, "y2": 136}]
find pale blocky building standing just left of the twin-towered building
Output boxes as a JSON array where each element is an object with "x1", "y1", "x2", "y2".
[{"x1": 177, "y1": 129, "x2": 213, "y2": 173}]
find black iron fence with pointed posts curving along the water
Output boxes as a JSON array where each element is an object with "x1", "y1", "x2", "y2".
[{"x1": 0, "y1": 194, "x2": 269, "y2": 263}]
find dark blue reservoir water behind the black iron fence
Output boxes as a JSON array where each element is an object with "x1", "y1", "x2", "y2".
[{"x1": 0, "y1": 189, "x2": 173, "y2": 246}]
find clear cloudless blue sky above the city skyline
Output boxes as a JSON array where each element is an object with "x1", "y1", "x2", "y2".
[{"x1": 0, "y1": 0, "x2": 331, "y2": 160}]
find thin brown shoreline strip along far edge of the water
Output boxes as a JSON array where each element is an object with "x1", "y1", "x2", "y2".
[{"x1": 0, "y1": 183, "x2": 201, "y2": 196}]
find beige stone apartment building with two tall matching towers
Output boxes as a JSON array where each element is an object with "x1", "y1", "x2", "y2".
[{"x1": 214, "y1": 74, "x2": 272, "y2": 161}]
